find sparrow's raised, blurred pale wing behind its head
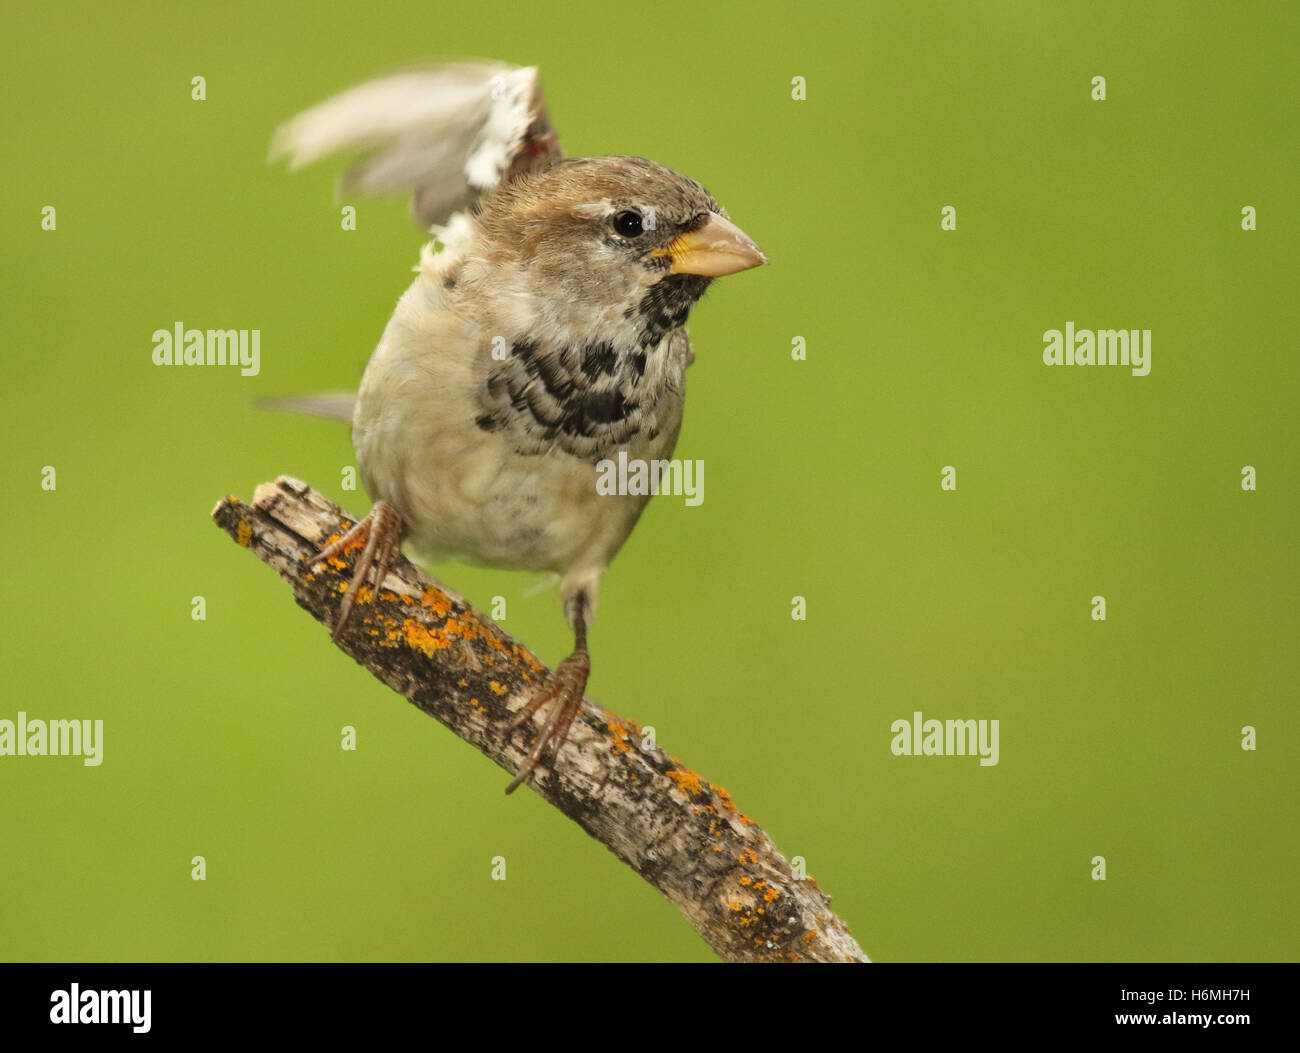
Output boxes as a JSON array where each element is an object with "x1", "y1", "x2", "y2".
[{"x1": 270, "y1": 62, "x2": 564, "y2": 229}]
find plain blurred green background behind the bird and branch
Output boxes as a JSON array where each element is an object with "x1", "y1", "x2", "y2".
[{"x1": 0, "y1": 0, "x2": 1300, "y2": 961}]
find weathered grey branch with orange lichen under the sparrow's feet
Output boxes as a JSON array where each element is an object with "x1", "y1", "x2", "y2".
[{"x1": 212, "y1": 476, "x2": 867, "y2": 962}]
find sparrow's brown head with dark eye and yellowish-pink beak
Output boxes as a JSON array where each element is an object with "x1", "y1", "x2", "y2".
[{"x1": 475, "y1": 157, "x2": 767, "y2": 346}]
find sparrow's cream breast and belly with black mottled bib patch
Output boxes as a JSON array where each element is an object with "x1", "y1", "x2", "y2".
[{"x1": 354, "y1": 279, "x2": 690, "y2": 571}]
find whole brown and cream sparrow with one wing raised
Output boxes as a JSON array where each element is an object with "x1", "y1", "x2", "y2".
[{"x1": 270, "y1": 60, "x2": 767, "y2": 794}]
